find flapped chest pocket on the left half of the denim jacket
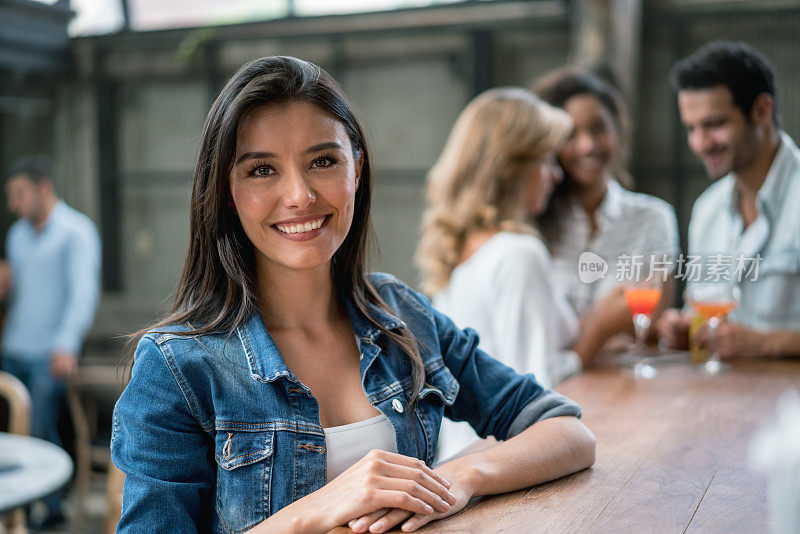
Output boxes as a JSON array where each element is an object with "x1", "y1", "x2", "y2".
[{"x1": 214, "y1": 429, "x2": 275, "y2": 533}]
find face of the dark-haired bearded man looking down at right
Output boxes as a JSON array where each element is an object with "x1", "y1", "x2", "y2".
[{"x1": 678, "y1": 85, "x2": 760, "y2": 180}]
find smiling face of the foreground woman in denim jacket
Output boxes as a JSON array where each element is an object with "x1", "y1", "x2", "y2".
[{"x1": 230, "y1": 102, "x2": 361, "y2": 282}]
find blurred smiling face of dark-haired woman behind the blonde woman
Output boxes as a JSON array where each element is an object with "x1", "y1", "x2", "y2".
[{"x1": 558, "y1": 94, "x2": 619, "y2": 188}]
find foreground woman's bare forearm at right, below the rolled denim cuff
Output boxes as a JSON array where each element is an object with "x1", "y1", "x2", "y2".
[{"x1": 443, "y1": 416, "x2": 595, "y2": 496}]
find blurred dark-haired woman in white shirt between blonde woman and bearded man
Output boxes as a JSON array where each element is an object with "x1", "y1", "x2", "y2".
[{"x1": 531, "y1": 69, "x2": 679, "y2": 363}]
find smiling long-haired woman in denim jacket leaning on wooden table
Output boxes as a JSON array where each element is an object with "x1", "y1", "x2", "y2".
[{"x1": 112, "y1": 57, "x2": 594, "y2": 532}]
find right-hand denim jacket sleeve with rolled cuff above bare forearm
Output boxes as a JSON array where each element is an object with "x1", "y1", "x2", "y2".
[{"x1": 433, "y1": 310, "x2": 581, "y2": 440}]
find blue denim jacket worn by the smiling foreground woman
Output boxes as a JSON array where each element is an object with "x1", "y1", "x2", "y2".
[{"x1": 111, "y1": 274, "x2": 580, "y2": 533}]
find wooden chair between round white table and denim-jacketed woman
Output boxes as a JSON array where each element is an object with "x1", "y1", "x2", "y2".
[{"x1": 67, "y1": 364, "x2": 123, "y2": 532}]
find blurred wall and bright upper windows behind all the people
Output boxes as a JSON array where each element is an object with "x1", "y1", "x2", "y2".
[{"x1": 0, "y1": 0, "x2": 800, "y2": 358}]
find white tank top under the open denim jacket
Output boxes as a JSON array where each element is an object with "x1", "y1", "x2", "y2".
[{"x1": 323, "y1": 414, "x2": 397, "y2": 483}]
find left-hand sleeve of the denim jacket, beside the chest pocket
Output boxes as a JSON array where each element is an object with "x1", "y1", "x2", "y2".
[{"x1": 111, "y1": 337, "x2": 216, "y2": 533}]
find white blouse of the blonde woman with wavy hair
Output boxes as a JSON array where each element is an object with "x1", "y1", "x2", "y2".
[{"x1": 433, "y1": 232, "x2": 581, "y2": 459}]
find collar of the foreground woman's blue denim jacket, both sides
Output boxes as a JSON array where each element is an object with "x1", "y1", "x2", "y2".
[{"x1": 231, "y1": 298, "x2": 406, "y2": 384}]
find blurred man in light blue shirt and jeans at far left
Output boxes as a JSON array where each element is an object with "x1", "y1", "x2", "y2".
[{"x1": 0, "y1": 156, "x2": 100, "y2": 522}]
